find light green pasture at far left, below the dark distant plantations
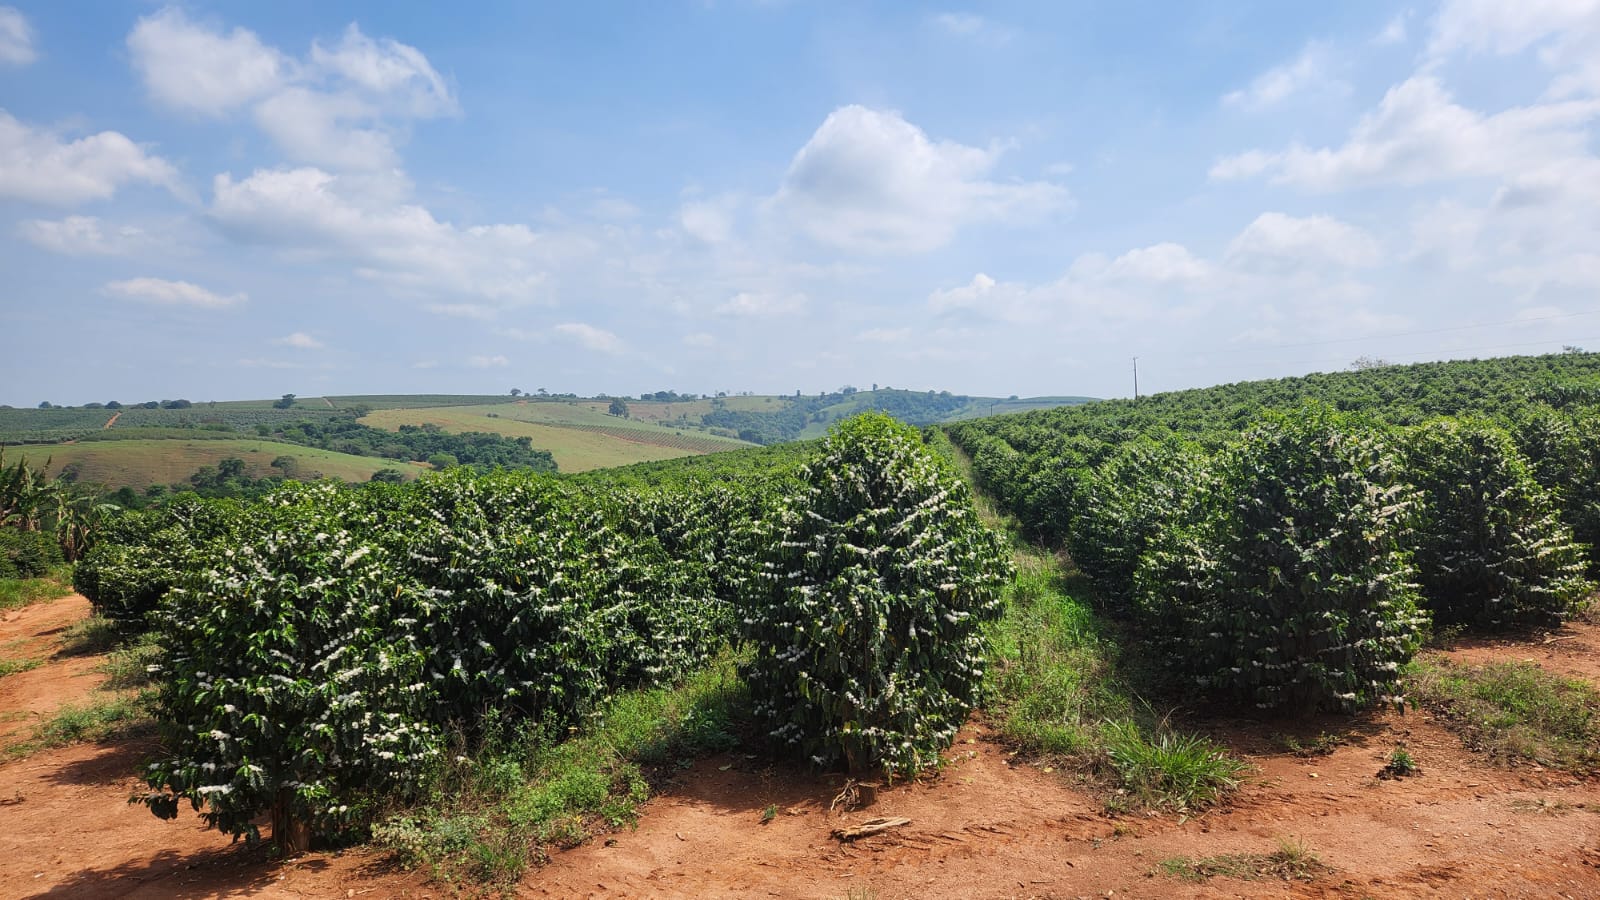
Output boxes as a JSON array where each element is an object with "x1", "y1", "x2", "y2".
[{"x1": 6, "y1": 439, "x2": 422, "y2": 490}]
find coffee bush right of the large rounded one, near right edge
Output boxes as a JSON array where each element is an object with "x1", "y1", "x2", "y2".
[{"x1": 1405, "y1": 420, "x2": 1594, "y2": 628}]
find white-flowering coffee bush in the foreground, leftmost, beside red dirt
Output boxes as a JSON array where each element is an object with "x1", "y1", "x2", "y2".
[{"x1": 144, "y1": 484, "x2": 440, "y2": 838}]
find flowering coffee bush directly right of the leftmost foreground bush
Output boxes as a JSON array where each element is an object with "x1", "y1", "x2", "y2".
[{"x1": 384, "y1": 471, "x2": 728, "y2": 730}]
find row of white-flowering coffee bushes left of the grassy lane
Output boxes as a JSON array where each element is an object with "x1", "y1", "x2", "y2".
[{"x1": 83, "y1": 416, "x2": 1006, "y2": 834}]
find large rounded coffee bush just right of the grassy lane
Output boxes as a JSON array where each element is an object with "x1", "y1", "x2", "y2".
[{"x1": 1136, "y1": 407, "x2": 1426, "y2": 713}]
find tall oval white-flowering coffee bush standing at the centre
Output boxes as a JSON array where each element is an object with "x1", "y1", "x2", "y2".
[{"x1": 742, "y1": 413, "x2": 1010, "y2": 773}]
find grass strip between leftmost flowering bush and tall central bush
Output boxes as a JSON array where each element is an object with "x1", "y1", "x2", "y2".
[{"x1": 373, "y1": 658, "x2": 746, "y2": 889}]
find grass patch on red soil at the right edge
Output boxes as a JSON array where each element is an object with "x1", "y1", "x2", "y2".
[{"x1": 1410, "y1": 660, "x2": 1600, "y2": 772}]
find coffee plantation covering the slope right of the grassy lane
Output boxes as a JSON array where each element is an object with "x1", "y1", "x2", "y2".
[{"x1": 947, "y1": 352, "x2": 1600, "y2": 714}]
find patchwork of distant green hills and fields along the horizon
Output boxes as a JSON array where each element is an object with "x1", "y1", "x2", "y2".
[{"x1": 0, "y1": 389, "x2": 1090, "y2": 488}]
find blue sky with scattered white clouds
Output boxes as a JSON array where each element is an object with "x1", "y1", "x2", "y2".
[{"x1": 0, "y1": 0, "x2": 1600, "y2": 398}]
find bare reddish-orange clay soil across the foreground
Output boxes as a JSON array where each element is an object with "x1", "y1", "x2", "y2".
[{"x1": 0, "y1": 597, "x2": 1600, "y2": 900}]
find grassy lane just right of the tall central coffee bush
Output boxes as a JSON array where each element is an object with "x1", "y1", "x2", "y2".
[{"x1": 989, "y1": 548, "x2": 1248, "y2": 812}]
